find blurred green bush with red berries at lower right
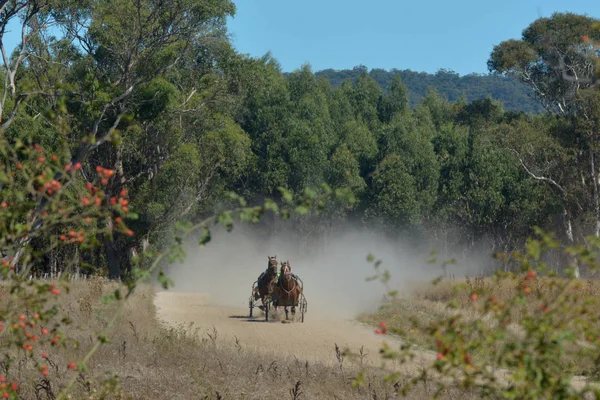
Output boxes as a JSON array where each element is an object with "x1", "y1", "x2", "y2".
[{"x1": 359, "y1": 231, "x2": 600, "y2": 399}]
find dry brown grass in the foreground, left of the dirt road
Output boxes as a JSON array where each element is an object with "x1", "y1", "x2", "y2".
[{"x1": 0, "y1": 280, "x2": 486, "y2": 400}]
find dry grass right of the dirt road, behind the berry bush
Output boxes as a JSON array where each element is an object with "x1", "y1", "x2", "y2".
[{"x1": 358, "y1": 277, "x2": 600, "y2": 378}]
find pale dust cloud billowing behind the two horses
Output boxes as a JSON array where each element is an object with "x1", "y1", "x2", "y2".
[{"x1": 167, "y1": 225, "x2": 488, "y2": 318}]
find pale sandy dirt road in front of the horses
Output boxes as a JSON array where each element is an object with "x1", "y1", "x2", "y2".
[{"x1": 155, "y1": 292, "x2": 431, "y2": 368}]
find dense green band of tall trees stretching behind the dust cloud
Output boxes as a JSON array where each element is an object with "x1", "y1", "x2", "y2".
[{"x1": 0, "y1": 0, "x2": 600, "y2": 277}]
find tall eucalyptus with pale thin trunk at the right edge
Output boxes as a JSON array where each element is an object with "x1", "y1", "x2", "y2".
[{"x1": 488, "y1": 13, "x2": 600, "y2": 274}]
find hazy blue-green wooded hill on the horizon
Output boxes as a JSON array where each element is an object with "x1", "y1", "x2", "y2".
[{"x1": 315, "y1": 66, "x2": 543, "y2": 113}]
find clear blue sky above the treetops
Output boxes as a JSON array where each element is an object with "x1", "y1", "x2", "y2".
[{"x1": 228, "y1": 0, "x2": 600, "y2": 75}]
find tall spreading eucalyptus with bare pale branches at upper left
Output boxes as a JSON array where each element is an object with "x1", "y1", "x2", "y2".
[{"x1": 21, "y1": 0, "x2": 235, "y2": 278}]
